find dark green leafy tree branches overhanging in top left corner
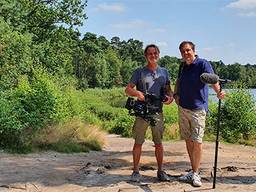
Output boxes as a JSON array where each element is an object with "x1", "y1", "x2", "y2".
[{"x1": 0, "y1": 0, "x2": 87, "y2": 42}]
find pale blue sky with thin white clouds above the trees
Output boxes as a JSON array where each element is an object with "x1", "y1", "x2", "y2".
[{"x1": 80, "y1": 0, "x2": 256, "y2": 64}]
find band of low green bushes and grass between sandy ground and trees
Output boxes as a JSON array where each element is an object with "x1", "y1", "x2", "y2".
[{"x1": 0, "y1": 85, "x2": 256, "y2": 152}]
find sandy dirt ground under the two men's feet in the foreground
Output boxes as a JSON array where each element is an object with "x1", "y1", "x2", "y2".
[{"x1": 0, "y1": 135, "x2": 256, "y2": 192}]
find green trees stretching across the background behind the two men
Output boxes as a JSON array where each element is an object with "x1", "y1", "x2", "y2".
[{"x1": 0, "y1": 0, "x2": 256, "y2": 93}]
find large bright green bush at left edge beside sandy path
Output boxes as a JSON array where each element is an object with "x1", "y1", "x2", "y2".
[{"x1": 0, "y1": 70, "x2": 71, "y2": 151}]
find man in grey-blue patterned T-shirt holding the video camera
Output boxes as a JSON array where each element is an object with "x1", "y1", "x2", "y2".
[{"x1": 125, "y1": 44, "x2": 173, "y2": 182}]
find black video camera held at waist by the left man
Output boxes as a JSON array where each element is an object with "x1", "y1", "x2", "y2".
[{"x1": 125, "y1": 93, "x2": 167, "y2": 126}]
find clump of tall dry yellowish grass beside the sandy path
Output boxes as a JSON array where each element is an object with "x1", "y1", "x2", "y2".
[{"x1": 32, "y1": 119, "x2": 106, "y2": 153}]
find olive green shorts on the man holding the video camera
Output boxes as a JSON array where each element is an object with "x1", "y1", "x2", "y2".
[{"x1": 133, "y1": 113, "x2": 164, "y2": 144}]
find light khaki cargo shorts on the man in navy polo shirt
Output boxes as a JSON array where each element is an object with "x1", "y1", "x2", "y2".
[{"x1": 179, "y1": 106, "x2": 206, "y2": 143}]
